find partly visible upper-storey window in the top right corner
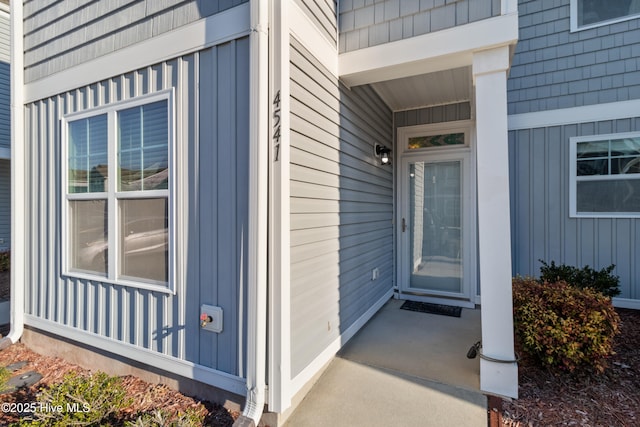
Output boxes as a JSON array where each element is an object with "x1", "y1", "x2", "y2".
[{"x1": 571, "y1": 0, "x2": 640, "y2": 31}]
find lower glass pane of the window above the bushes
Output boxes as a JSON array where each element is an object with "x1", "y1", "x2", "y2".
[{"x1": 576, "y1": 179, "x2": 640, "y2": 213}]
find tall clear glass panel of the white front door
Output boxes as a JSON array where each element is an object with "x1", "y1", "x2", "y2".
[{"x1": 407, "y1": 160, "x2": 464, "y2": 294}]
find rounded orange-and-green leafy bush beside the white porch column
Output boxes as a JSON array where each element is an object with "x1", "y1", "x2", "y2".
[{"x1": 513, "y1": 278, "x2": 620, "y2": 372}]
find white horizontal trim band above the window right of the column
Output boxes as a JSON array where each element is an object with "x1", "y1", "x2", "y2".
[{"x1": 508, "y1": 99, "x2": 640, "y2": 130}]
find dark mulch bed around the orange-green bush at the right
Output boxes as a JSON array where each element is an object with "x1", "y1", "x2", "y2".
[{"x1": 488, "y1": 309, "x2": 640, "y2": 427}]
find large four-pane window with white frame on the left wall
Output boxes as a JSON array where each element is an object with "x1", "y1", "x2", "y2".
[{"x1": 63, "y1": 92, "x2": 174, "y2": 289}]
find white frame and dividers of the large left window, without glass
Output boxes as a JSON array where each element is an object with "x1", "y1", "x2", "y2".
[{"x1": 61, "y1": 89, "x2": 177, "y2": 293}]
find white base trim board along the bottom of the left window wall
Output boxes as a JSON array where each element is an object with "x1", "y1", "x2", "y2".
[{"x1": 24, "y1": 314, "x2": 246, "y2": 396}]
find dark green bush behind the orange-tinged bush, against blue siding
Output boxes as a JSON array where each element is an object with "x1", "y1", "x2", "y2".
[{"x1": 539, "y1": 260, "x2": 620, "y2": 297}]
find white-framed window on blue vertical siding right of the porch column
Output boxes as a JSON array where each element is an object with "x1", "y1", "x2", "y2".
[{"x1": 570, "y1": 133, "x2": 640, "y2": 217}]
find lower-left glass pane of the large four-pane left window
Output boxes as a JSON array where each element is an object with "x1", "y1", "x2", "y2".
[{"x1": 69, "y1": 200, "x2": 108, "y2": 275}]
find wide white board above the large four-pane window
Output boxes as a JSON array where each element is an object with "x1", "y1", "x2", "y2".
[{"x1": 24, "y1": 3, "x2": 250, "y2": 103}]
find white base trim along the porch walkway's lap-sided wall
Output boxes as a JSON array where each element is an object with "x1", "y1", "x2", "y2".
[{"x1": 291, "y1": 289, "x2": 394, "y2": 395}]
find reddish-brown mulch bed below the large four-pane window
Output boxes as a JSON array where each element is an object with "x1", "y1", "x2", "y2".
[{"x1": 0, "y1": 344, "x2": 239, "y2": 427}]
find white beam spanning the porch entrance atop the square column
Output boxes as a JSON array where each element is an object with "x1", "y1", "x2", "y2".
[{"x1": 338, "y1": 12, "x2": 518, "y2": 86}]
